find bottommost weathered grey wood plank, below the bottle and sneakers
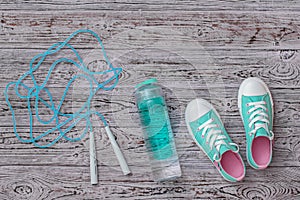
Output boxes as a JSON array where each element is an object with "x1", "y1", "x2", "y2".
[{"x1": 1, "y1": 166, "x2": 300, "y2": 199}]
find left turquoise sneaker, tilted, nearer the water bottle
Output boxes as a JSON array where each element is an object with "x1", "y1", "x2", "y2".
[{"x1": 185, "y1": 99, "x2": 246, "y2": 182}]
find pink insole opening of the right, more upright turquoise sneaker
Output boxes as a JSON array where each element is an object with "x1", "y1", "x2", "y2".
[{"x1": 251, "y1": 136, "x2": 271, "y2": 169}]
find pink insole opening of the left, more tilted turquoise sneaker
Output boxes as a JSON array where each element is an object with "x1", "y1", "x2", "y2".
[{"x1": 221, "y1": 151, "x2": 245, "y2": 181}]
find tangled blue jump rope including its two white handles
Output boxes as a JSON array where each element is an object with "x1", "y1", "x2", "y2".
[{"x1": 4, "y1": 30, "x2": 131, "y2": 184}]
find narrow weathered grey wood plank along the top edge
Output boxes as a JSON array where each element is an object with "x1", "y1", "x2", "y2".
[{"x1": 0, "y1": 0, "x2": 300, "y2": 12}]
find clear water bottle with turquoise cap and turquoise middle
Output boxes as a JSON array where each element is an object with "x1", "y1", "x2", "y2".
[{"x1": 134, "y1": 79, "x2": 181, "y2": 182}]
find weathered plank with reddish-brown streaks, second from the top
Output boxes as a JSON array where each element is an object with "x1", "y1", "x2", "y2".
[{"x1": 0, "y1": 11, "x2": 300, "y2": 49}]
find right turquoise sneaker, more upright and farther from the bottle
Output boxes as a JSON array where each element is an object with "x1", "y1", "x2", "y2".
[{"x1": 238, "y1": 78, "x2": 274, "y2": 169}]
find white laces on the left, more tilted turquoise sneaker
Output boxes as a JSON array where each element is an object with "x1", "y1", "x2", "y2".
[{"x1": 197, "y1": 118, "x2": 239, "y2": 161}]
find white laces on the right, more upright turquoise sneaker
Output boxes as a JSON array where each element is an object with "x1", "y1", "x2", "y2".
[{"x1": 246, "y1": 101, "x2": 274, "y2": 140}]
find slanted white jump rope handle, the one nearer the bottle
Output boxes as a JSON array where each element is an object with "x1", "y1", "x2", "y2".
[{"x1": 105, "y1": 126, "x2": 131, "y2": 175}]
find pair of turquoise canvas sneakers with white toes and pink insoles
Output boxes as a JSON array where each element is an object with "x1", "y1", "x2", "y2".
[{"x1": 185, "y1": 78, "x2": 274, "y2": 181}]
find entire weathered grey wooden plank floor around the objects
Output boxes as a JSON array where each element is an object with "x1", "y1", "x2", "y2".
[{"x1": 0, "y1": 0, "x2": 300, "y2": 200}]
